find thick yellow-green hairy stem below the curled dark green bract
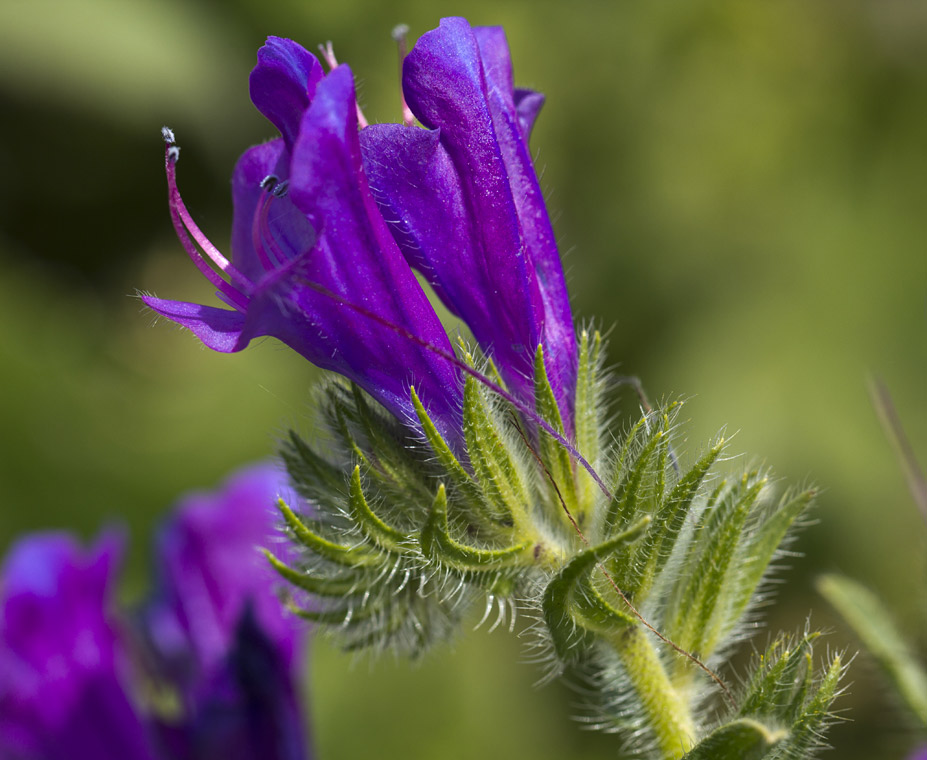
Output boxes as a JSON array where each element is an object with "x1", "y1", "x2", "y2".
[{"x1": 611, "y1": 626, "x2": 695, "y2": 760}]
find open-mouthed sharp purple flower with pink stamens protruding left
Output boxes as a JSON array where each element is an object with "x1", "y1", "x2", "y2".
[{"x1": 144, "y1": 37, "x2": 461, "y2": 442}]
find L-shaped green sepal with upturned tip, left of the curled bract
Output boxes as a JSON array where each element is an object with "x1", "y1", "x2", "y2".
[{"x1": 421, "y1": 483, "x2": 531, "y2": 573}]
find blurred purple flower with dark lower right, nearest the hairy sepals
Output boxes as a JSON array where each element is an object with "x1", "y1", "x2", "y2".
[{"x1": 140, "y1": 465, "x2": 305, "y2": 760}]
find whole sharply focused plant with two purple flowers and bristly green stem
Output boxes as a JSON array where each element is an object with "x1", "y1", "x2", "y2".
[{"x1": 144, "y1": 18, "x2": 843, "y2": 760}]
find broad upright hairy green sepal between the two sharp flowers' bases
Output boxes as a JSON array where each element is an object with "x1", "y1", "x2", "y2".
[{"x1": 463, "y1": 377, "x2": 528, "y2": 524}]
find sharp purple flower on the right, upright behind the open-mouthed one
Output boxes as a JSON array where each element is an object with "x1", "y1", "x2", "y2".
[{"x1": 361, "y1": 18, "x2": 577, "y2": 434}]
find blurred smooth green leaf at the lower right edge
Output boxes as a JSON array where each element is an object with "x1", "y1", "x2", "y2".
[{"x1": 816, "y1": 575, "x2": 927, "y2": 726}]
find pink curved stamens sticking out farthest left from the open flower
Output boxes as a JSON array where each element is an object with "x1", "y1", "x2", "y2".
[{"x1": 164, "y1": 140, "x2": 251, "y2": 311}]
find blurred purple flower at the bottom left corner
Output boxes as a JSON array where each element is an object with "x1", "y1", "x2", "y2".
[{"x1": 0, "y1": 534, "x2": 156, "y2": 760}]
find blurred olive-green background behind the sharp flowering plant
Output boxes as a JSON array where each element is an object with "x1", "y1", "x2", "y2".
[{"x1": 0, "y1": 0, "x2": 927, "y2": 760}]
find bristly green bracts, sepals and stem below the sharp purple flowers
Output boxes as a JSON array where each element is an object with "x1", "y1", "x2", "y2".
[{"x1": 268, "y1": 330, "x2": 843, "y2": 760}]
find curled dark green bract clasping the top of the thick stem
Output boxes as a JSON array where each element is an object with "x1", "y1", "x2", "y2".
[{"x1": 542, "y1": 516, "x2": 650, "y2": 661}]
